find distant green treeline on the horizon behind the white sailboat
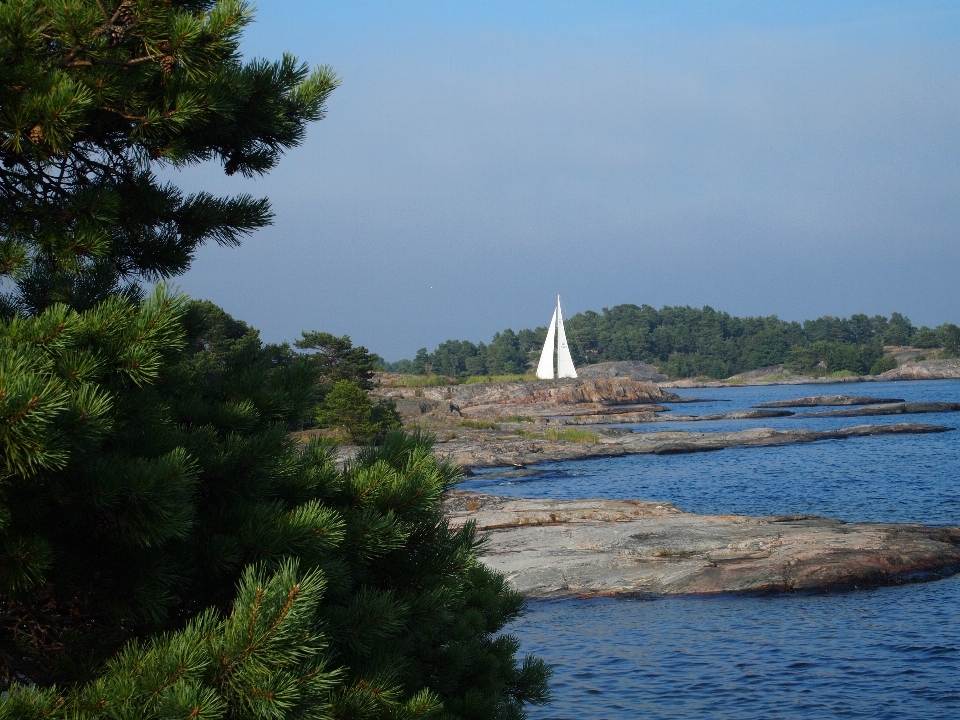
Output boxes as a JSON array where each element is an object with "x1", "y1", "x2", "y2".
[{"x1": 386, "y1": 305, "x2": 960, "y2": 378}]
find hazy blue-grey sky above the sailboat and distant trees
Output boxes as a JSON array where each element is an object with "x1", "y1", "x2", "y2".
[{"x1": 171, "y1": 0, "x2": 960, "y2": 360}]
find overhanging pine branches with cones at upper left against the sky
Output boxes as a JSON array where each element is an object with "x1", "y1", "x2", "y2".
[{"x1": 0, "y1": 0, "x2": 338, "y2": 313}]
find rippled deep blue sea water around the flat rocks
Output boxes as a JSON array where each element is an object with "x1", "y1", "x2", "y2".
[{"x1": 461, "y1": 380, "x2": 960, "y2": 720}]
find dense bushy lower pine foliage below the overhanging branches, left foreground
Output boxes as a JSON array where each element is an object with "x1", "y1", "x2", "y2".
[{"x1": 0, "y1": 289, "x2": 548, "y2": 718}]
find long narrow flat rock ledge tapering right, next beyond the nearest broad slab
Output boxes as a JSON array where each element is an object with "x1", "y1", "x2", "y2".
[{"x1": 435, "y1": 423, "x2": 952, "y2": 467}]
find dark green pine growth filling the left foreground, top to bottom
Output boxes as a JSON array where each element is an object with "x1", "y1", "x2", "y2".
[{"x1": 0, "y1": 0, "x2": 548, "y2": 719}]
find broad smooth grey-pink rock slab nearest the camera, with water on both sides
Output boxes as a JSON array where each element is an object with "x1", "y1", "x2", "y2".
[{"x1": 445, "y1": 490, "x2": 960, "y2": 598}]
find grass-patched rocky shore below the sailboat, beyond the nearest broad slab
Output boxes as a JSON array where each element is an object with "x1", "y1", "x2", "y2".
[{"x1": 364, "y1": 376, "x2": 960, "y2": 468}]
